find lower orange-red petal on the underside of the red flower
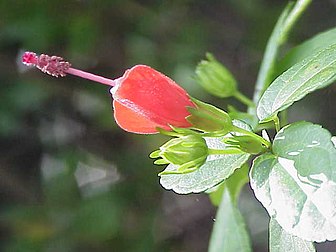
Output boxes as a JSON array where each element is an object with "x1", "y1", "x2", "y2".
[{"x1": 113, "y1": 100, "x2": 170, "y2": 134}]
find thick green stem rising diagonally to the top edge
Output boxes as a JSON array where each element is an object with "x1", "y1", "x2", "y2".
[{"x1": 249, "y1": 0, "x2": 312, "y2": 115}]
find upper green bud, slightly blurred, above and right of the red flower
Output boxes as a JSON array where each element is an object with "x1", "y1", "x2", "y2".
[{"x1": 196, "y1": 53, "x2": 237, "y2": 98}]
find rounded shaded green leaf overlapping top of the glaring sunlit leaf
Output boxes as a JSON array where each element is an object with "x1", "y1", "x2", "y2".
[{"x1": 273, "y1": 122, "x2": 336, "y2": 179}]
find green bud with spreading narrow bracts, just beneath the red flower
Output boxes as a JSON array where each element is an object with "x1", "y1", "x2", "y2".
[{"x1": 149, "y1": 134, "x2": 208, "y2": 175}]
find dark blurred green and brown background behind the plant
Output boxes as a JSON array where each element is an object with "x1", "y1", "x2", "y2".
[{"x1": 0, "y1": 0, "x2": 336, "y2": 252}]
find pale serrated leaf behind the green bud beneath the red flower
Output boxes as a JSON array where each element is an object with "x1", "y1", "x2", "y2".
[{"x1": 160, "y1": 120, "x2": 250, "y2": 194}]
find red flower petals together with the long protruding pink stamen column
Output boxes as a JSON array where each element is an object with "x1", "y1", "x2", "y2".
[{"x1": 22, "y1": 52, "x2": 196, "y2": 134}]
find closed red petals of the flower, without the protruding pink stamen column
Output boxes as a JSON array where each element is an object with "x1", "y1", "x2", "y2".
[{"x1": 111, "y1": 65, "x2": 195, "y2": 134}]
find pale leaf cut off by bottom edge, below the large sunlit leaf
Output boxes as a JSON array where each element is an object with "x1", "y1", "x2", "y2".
[{"x1": 269, "y1": 218, "x2": 315, "y2": 252}]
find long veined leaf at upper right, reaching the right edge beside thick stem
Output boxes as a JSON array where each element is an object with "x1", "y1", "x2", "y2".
[{"x1": 257, "y1": 44, "x2": 336, "y2": 122}]
